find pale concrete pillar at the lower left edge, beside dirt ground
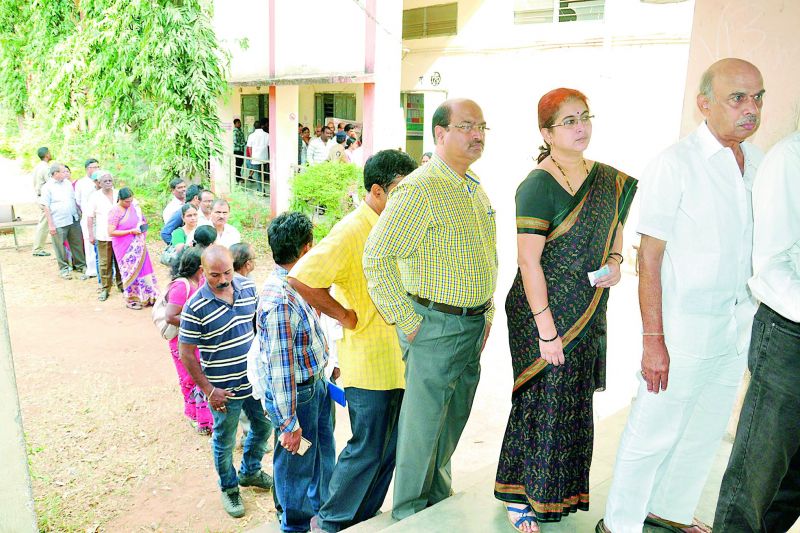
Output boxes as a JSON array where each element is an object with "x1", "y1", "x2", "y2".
[{"x1": 0, "y1": 264, "x2": 38, "y2": 532}]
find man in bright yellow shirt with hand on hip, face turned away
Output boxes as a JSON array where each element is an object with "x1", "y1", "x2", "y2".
[{"x1": 289, "y1": 150, "x2": 417, "y2": 532}]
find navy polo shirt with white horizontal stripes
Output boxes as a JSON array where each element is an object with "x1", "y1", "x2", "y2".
[{"x1": 178, "y1": 277, "x2": 258, "y2": 400}]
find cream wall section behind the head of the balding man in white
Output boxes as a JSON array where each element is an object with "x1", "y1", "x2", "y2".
[{"x1": 681, "y1": 0, "x2": 800, "y2": 149}]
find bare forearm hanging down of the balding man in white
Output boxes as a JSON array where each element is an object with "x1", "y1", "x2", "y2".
[{"x1": 639, "y1": 235, "x2": 669, "y2": 394}]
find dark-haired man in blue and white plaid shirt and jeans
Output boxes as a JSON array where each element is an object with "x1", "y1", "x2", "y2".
[{"x1": 250, "y1": 213, "x2": 335, "y2": 531}]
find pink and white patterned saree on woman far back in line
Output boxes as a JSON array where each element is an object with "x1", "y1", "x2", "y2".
[{"x1": 108, "y1": 204, "x2": 158, "y2": 306}]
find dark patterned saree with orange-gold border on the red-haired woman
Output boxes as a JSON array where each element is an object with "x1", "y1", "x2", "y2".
[{"x1": 495, "y1": 163, "x2": 636, "y2": 522}]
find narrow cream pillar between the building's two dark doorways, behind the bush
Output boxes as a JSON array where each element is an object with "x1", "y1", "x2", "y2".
[{"x1": 269, "y1": 85, "x2": 300, "y2": 217}]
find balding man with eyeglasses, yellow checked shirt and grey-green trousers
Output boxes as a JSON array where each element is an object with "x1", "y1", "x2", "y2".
[{"x1": 363, "y1": 100, "x2": 497, "y2": 519}]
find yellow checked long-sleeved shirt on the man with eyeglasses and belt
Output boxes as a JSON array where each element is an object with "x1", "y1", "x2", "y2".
[{"x1": 363, "y1": 155, "x2": 497, "y2": 334}]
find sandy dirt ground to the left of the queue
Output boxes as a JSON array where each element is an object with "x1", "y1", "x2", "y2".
[{"x1": 0, "y1": 208, "x2": 282, "y2": 531}]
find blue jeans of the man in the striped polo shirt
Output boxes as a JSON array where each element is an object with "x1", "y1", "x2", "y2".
[{"x1": 211, "y1": 396, "x2": 272, "y2": 491}]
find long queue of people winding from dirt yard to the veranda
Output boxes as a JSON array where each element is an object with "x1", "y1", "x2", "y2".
[{"x1": 28, "y1": 54, "x2": 800, "y2": 533}]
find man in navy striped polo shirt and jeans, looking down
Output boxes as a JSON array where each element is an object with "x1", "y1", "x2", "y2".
[{"x1": 179, "y1": 245, "x2": 272, "y2": 518}]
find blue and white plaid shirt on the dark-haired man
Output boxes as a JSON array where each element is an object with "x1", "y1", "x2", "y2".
[{"x1": 255, "y1": 265, "x2": 328, "y2": 432}]
